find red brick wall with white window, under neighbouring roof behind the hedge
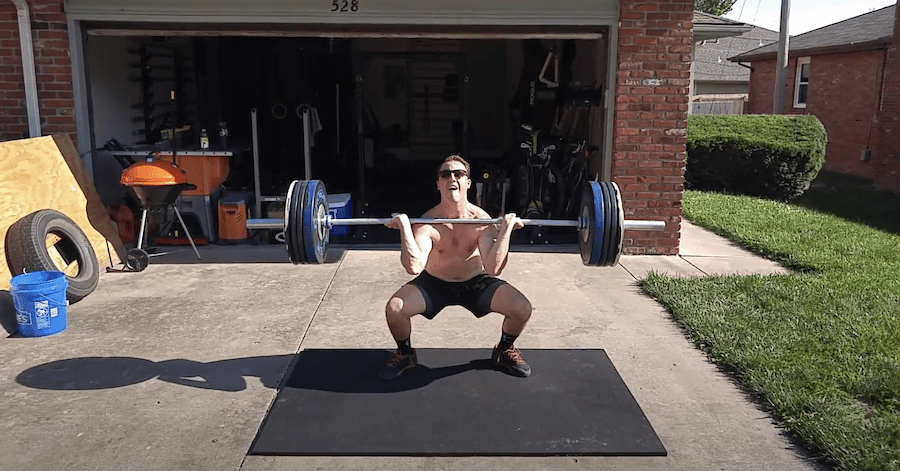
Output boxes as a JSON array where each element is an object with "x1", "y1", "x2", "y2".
[{"x1": 749, "y1": 49, "x2": 884, "y2": 183}]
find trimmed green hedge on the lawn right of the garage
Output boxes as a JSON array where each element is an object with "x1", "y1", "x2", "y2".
[{"x1": 685, "y1": 115, "x2": 827, "y2": 200}]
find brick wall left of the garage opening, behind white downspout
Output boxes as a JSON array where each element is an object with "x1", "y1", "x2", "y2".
[{"x1": 0, "y1": 0, "x2": 76, "y2": 141}]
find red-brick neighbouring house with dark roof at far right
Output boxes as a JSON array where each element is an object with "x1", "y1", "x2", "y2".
[{"x1": 728, "y1": 5, "x2": 900, "y2": 191}]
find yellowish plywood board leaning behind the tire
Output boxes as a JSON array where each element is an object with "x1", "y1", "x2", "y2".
[{"x1": 0, "y1": 135, "x2": 125, "y2": 290}]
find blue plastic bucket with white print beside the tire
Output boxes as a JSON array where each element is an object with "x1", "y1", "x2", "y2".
[{"x1": 9, "y1": 271, "x2": 69, "y2": 337}]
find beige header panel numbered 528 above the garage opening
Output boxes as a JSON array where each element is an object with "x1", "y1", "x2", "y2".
[{"x1": 65, "y1": 0, "x2": 618, "y2": 27}]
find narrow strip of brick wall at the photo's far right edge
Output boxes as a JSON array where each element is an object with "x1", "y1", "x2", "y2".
[{"x1": 872, "y1": 8, "x2": 900, "y2": 192}]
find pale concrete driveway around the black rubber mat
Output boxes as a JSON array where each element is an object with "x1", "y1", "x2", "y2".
[{"x1": 0, "y1": 223, "x2": 820, "y2": 471}]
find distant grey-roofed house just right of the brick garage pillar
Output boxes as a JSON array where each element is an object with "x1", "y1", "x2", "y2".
[{"x1": 691, "y1": 11, "x2": 778, "y2": 114}]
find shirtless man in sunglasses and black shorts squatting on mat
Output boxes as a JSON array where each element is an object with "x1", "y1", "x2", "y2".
[{"x1": 378, "y1": 155, "x2": 531, "y2": 380}]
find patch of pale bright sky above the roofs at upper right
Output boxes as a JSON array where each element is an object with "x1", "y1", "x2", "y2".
[{"x1": 722, "y1": 0, "x2": 897, "y2": 36}]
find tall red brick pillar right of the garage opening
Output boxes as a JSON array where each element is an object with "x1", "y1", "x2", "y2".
[{"x1": 612, "y1": 0, "x2": 694, "y2": 255}]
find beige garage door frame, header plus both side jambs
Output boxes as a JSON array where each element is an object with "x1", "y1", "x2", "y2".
[{"x1": 65, "y1": 0, "x2": 619, "y2": 197}]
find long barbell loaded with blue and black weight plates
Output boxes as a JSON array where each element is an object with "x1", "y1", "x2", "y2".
[{"x1": 247, "y1": 180, "x2": 666, "y2": 267}]
